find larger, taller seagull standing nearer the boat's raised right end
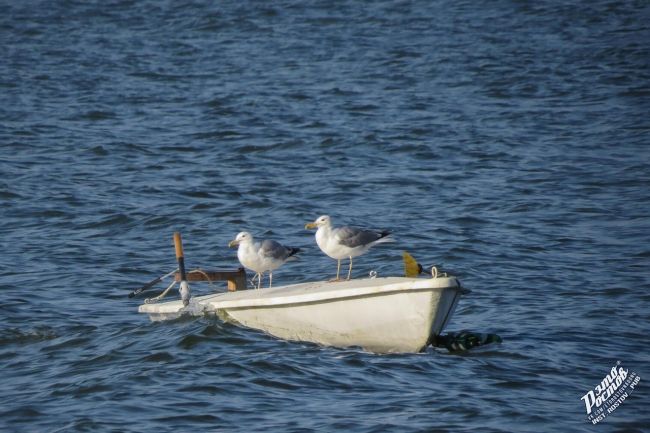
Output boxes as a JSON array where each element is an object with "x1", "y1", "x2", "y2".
[{"x1": 305, "y1": 215, "x2": 392, "y2": 281}]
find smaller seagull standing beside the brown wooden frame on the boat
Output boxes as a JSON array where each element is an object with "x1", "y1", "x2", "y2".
[{"x1": 228, "y1": 232, "x2": 300, "y2": 289}]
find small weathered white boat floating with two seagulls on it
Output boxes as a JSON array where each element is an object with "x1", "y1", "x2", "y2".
[{"x1": 139, "y1": 276, "x2": 468, "y2": 353}]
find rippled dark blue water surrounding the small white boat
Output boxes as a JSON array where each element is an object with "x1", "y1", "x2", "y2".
[{"x1": 0, "y1": 0, "x2": 650, "y2": 433}]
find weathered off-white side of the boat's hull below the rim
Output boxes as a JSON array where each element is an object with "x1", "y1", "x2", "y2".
[{"x1": 221, "y1": 291, "x2": 440, "y2": 353}]
